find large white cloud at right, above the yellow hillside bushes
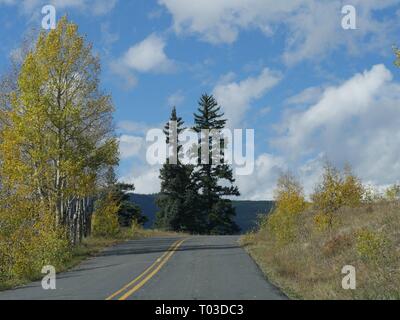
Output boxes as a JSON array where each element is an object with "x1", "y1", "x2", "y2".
[{"x1": 272, "y1": 65, "x2": 400, "y2": 186}]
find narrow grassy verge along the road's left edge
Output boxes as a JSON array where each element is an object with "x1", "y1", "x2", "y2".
[{"x1": 0, "y1": 228, "x2": 182, "y2": 291}]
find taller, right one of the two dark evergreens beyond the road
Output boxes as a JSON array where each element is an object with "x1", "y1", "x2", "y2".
[{"x1": 193, "y1": 94, "x2": 240, "y2": 234}]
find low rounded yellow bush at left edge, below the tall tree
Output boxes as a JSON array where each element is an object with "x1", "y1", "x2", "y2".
[{"x1": 0, "y1": 197, "x2": 71, "y2": 281}]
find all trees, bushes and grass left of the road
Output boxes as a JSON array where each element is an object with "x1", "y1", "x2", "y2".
[{"x1": 0, "y1": 18, "x2": 156, "y2": 289}]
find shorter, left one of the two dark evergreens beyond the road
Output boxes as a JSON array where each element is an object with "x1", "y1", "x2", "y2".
[{"x1": 156, "y1": 108, "x2": 199, "y2": 232}]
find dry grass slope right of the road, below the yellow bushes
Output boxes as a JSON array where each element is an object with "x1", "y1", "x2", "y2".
[{"x1": 241, "y1": 202, "x2": 400, "y2": 299}]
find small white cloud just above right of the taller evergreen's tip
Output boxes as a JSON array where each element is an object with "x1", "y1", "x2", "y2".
[{"x1": 213, "y1": 68, "x2": 282, "y2": 127}]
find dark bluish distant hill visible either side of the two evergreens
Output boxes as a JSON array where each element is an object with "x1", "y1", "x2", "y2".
[{"x1": 131, "y1": 193, "x2": 274, "y2": 232}]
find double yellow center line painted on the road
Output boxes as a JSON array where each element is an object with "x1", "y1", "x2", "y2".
[{"x1": 106, "y1": 239, "x2": 187, "y2": 300}]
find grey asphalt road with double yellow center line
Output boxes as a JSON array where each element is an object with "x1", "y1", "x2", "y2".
[{"x1": 0, "y1": 236, "x2": 285, "y2": 300}]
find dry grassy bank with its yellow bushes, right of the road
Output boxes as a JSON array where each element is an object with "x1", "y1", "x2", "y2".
[{"x1": 241, "y1": 163, "x2": 400, "y2": 299}]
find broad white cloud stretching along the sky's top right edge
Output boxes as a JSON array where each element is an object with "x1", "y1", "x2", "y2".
[{"x1": 159, "y1": 0, "x2": 399, "y2": 64}]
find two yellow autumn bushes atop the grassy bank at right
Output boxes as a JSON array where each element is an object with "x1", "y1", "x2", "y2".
[{"x1": 266, "y1": 162, "x2": 374, "y2": 244}]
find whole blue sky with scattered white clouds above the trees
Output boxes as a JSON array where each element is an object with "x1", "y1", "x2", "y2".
[{"x1": 0, "y1": 0, "x2": 400, "y2": 199}]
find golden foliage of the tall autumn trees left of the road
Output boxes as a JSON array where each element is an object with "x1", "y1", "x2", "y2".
[{"x1": 0, "y1": 17, "x2": 118, "y2": 281}]
